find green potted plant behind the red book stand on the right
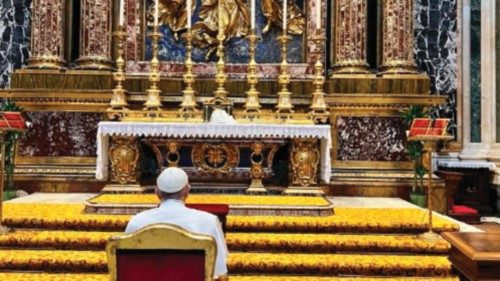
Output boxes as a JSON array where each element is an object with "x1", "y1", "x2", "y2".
[{"x1": 401, "y1": 105, "x2": 427, "y2": 194}]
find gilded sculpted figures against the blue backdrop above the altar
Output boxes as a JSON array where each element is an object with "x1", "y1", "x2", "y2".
[{"x1": 147, "y1": 0, "x2": 306, "y2": 48}]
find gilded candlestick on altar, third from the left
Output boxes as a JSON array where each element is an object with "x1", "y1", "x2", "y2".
[{"x1": 180, "y1": 28, "x2": 197, "y2": 119}]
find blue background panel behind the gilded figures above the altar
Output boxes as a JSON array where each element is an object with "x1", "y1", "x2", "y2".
[{"x1": 145, "y1": 0, "x2": 305, "y2": 63}]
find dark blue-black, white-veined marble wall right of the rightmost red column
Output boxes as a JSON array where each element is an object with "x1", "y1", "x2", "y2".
[{"x1": 415, "y1": 0, "x2": 458, "y2": 137}]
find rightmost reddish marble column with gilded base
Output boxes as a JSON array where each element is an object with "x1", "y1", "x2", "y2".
[{"x1": 380, "y1": 0, "x2": 418, "y2": 75}]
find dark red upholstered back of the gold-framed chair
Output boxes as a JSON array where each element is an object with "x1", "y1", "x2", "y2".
[{"x1": 116, "y1": 250, "x2": 205, "y2": 281}]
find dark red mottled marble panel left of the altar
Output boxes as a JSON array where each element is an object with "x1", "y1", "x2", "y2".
[{"x1": 19, "y1": 112, "x2": 102, "y2": 157}]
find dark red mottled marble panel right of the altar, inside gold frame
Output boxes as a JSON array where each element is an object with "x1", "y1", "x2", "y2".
[{"x1": 334, "y1": 116, "x2": 407, "y2": 161}]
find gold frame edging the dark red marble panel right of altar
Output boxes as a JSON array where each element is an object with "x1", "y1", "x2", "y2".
[{"x1": 330, "y1": 108, "x2": 412, "y2": 169}]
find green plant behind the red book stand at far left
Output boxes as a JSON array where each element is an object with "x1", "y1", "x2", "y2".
[{"x1": 0, "y1": 99, "x2": 22, "y2": 190}]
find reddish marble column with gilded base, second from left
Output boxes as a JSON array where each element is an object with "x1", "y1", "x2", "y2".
[{"x1": 77, "y1": 0, "x2": 113, "y2": 70}]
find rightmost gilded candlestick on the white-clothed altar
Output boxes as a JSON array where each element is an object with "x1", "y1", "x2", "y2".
[{"x1": 309, "y1": 29, "x2": 330, "y2": 124}]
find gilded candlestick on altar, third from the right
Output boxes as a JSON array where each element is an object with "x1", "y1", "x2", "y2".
[{"x1": 245, "y1": 29, "x2": 261, "y2": 120}]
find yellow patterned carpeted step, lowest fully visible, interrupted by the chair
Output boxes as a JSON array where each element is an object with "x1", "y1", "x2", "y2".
[{"x1": 0, "y1": 250, "x2": 451, "y2": 280}]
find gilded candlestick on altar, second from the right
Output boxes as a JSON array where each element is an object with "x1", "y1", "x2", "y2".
[{"x1": 276, "y1": 33, "x2": 293, "y2": 120}]
